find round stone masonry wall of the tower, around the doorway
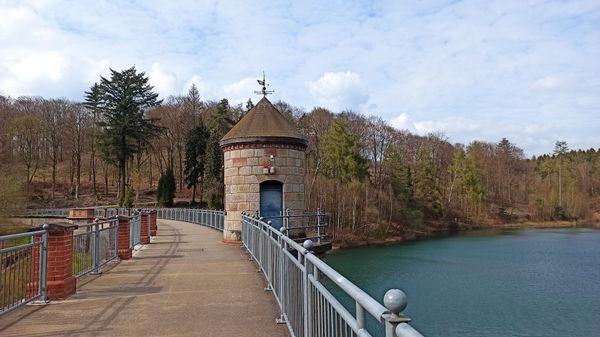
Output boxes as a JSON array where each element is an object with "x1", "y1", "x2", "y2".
[{"x1": 223, "y1": 145, "x2": 305, "y2": 241}]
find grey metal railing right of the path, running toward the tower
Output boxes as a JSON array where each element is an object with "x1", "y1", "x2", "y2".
[{"x1": 242, "y1": 214, "x2": 422, "y2": 337}]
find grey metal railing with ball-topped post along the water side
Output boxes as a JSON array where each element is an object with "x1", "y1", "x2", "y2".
[{"x1": 242, "y1": 214, "x2": 422, "y2": 337}]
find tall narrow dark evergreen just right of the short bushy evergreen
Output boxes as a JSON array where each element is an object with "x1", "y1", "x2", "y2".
[{"x1": 185, "y1": 121, "x2": 209, "y2": 203}]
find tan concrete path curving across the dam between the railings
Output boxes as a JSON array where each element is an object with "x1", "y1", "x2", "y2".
[{"x1": 0, "y1": 220, "x2": 289, "y2": 337}]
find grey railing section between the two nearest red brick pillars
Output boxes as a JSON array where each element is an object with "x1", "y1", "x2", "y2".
[{"x1": 73, "y1": 218, "x2": 119, "y2": 277}]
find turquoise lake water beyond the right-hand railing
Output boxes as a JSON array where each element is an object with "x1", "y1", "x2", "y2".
[{"x1": 327, "y1": 229, "x2": 600, "y2": 337}]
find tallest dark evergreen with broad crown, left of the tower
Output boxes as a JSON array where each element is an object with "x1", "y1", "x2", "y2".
[{"x1": 90, "y1": 67, "x2": 161, "y2": 201}]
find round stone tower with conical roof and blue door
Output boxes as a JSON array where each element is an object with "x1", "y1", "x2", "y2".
[{"x1": 220, "y1": 97, "x2": 308, "y2": 241}]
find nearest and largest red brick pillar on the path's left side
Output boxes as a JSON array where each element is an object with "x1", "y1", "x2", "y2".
[{"x1": 47, "y1": 223, "x2": 77, "y2": 300}]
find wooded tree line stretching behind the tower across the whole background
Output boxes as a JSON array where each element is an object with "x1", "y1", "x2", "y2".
[{"x1": 0, "y1": 68, "x2": 600, "y2": 240}]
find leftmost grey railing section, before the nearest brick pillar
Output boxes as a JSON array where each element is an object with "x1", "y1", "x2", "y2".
[{"x1": 0, "y1": 225, "x2": 48, "y2": 315}]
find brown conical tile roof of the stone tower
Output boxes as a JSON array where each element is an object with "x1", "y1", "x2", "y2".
[{"x1": 220, "y1": 97, "x2": 308, "y2": 146}]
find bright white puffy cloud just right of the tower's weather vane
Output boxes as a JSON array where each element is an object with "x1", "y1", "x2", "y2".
[{"x1": 308, "y1": 71, "x2": 369, "y2": 111}]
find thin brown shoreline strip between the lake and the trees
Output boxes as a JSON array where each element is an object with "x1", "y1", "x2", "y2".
[{"x1": 331, "y1": 221, "x2": 600, "y2": 250}]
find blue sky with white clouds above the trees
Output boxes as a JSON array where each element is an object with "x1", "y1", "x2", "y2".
[{"x1": 0, "y1": 0, "x2": 600, "y2": 155}]
